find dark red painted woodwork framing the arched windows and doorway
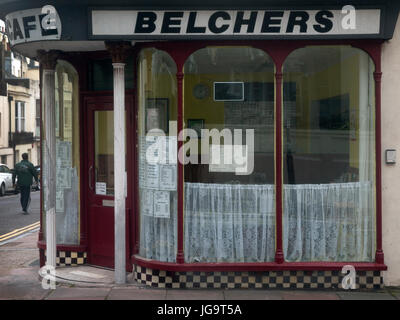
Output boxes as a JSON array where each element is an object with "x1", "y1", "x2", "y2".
[{"x1": 39, "y1": 40, "x2": 387, "y2": 271}]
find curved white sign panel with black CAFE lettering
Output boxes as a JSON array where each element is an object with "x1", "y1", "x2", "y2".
[{"x1": 6, "y1": 5, "x2": 62, "y2": 46}]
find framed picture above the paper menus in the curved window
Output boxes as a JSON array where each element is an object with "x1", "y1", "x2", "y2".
[{"x1": 146, "y1": 98, "x2": 169, "y2": 134}]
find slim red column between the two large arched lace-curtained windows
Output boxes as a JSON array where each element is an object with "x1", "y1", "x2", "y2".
[{"x1": 275, "y1": 64, "x2": 284, "y2": 263}]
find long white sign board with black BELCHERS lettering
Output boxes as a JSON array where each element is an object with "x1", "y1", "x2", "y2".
[{"x1": 90, "y1": 6, "x2": 381, "y2": 39}]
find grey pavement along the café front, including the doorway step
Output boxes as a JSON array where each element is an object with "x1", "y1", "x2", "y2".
[{"x1": 0, "y1": 231, "x2": 400, "y2": 301}]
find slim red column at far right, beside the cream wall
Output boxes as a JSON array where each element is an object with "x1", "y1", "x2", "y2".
[{"x1": 374, "y1": 70, "x2": 384, "y2": 264}]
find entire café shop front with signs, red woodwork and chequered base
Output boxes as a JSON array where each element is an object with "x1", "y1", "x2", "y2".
[{"x1": 1, "y1": 1, "x2": 400, "y2": 288}]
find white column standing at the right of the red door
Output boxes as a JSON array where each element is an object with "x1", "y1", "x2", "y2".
[{"x1": 113, "y1": 63, "x2": 126, "y2": 284}]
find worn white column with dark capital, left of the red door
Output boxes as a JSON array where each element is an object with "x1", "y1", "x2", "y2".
[{"x1": 38, "y1": 51, "x2": 58, "y2": 268}]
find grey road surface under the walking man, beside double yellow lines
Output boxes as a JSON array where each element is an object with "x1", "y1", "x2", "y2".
[{"x1": 0, "y1": 191, "x2": 40, "y2": 237}]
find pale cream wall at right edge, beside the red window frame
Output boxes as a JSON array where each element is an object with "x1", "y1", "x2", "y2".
[{"x1": 381, "y1": 13, "x2": 400, "y2": 286}]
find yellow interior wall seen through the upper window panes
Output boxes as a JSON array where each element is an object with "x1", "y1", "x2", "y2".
[{"x1": 139, "y1": 49, "x2": 368, "y2": 172}]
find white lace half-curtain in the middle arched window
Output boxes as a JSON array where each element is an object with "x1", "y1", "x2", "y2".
[{"x1": 185, "y1": 183, "x2": 275, "y2": 263}]
